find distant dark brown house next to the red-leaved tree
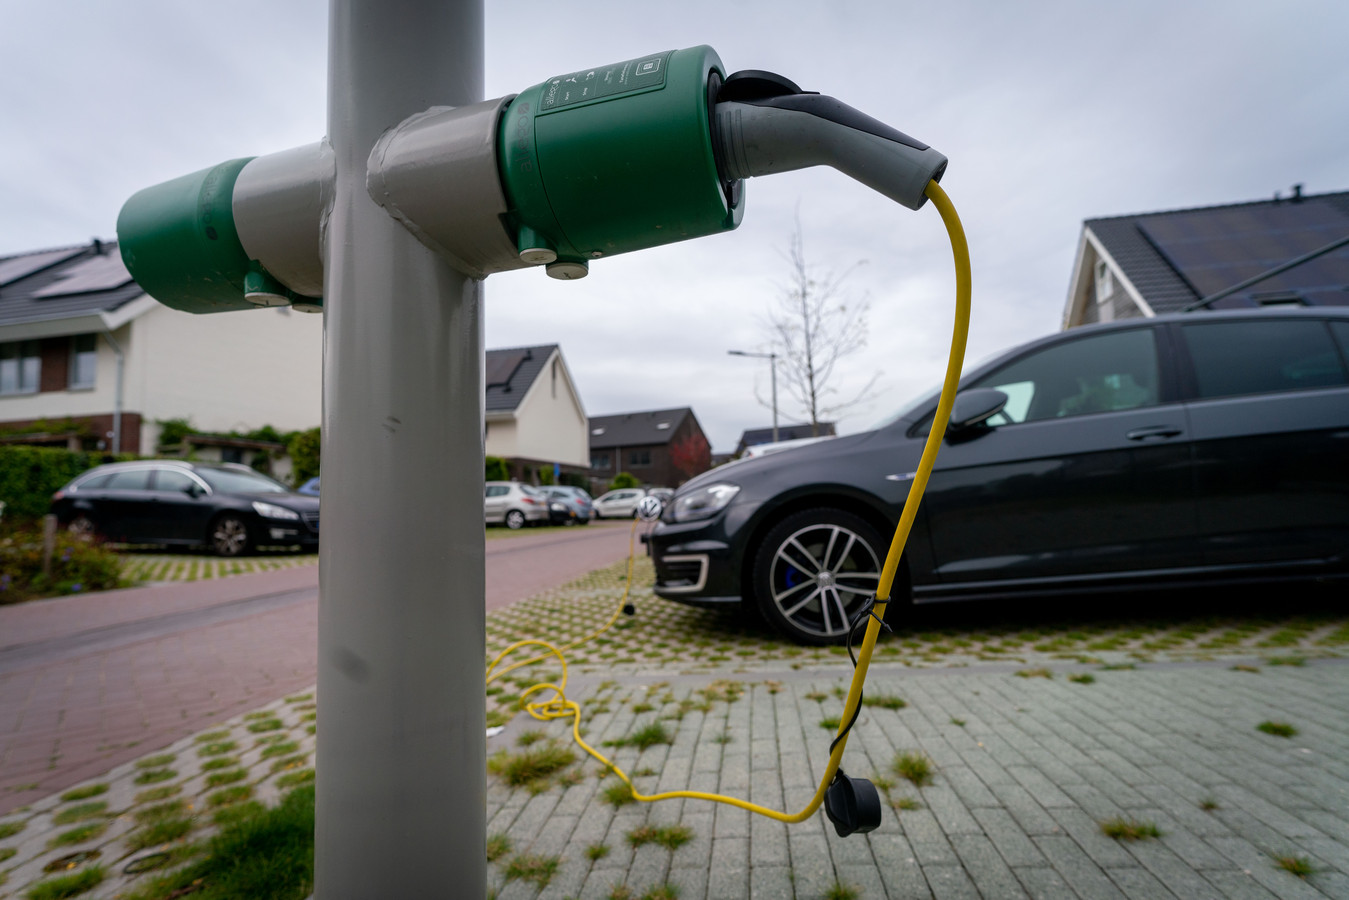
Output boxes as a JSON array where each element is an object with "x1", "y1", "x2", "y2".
[{"x1": 590, "y1": 406, "x2": 712, "y2": 491}]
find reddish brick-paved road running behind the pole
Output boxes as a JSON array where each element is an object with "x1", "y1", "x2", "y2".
[{"x1": 0, "y1": 522, "x2": 641, "y2": 815}]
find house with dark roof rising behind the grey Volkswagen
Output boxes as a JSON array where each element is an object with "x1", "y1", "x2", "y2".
[{"x1": 1063, "y1": 185, "x2": 1349, "y2": 328}]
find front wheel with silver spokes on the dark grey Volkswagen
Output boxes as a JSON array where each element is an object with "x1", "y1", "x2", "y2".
[{"x1": 753, "y1": 509, "x2": 886, "y2": 645}]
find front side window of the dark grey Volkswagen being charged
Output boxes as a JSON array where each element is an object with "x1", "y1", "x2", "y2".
[{"x1": 969, "y1": 328, "x2": 1159, "y2": 425}]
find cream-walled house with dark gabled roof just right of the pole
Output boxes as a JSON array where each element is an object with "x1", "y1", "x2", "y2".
[{"x1": 484, "y1": 344, "x2": 590, "y2": 483}]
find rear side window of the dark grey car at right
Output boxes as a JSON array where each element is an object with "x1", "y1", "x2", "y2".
[{"x1": 1182, "y1": 318, "x2": 1349, "y2": 398}]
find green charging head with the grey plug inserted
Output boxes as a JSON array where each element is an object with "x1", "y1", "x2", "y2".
[{"x1": 498, "y1": 46, "x2": 743, "y2": 278}]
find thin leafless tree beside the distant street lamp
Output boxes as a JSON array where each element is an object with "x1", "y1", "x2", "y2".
[{"x1": 759, "y1": 217, "x2": 881, "y2": 436}]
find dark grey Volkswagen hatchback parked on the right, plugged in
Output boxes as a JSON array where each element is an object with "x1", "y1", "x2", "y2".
[{"x1": 649, "y1": 308, "x2": 1349, "y2": 644}]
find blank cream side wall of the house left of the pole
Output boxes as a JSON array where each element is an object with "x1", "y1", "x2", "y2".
[{"x1": 132, "y1": 306, "x2": 324, "y2": 452}]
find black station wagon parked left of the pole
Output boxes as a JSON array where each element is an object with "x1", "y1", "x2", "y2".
[{"x1": 51, "y1": 460, "x2": 318, "y2": 556}]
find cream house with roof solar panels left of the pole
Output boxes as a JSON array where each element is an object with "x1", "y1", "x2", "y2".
[{"x1": 0, "y1": 240, "x2": 322, "y2": 463}]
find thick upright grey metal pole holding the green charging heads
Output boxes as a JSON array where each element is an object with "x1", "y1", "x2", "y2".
[{"x1": 314, "y1": 0, "x2": 487, "y2": 900}]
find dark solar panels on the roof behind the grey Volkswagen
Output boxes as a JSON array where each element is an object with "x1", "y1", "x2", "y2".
[{"x1": 1137, "y1": 201, "x2": 1349, "y2": 297}]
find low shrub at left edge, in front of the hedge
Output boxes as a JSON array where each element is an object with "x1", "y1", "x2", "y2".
[{"x1": 0, "y1": 525, "x2": 127, "y2": 604}]
